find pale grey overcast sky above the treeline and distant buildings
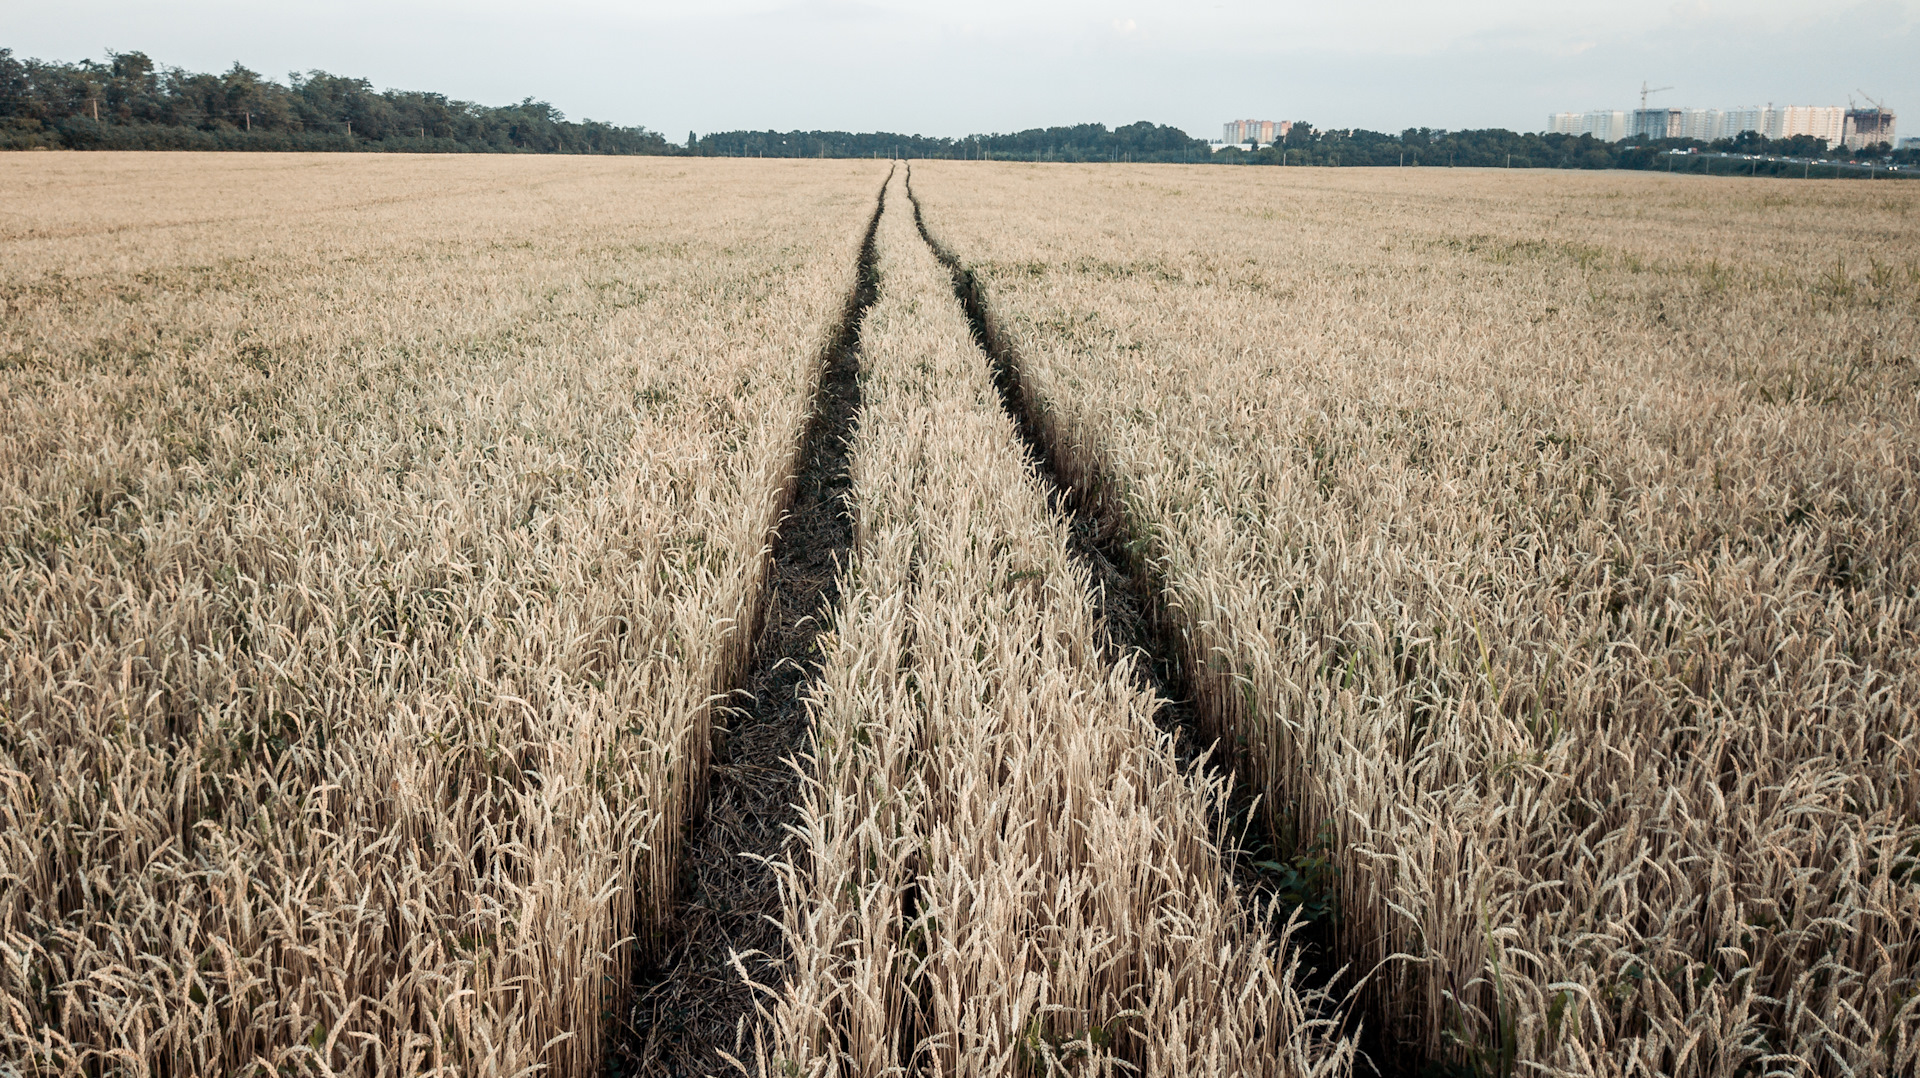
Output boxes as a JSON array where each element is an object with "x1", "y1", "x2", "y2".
[{"x1": 0, "y1": 0, "x2": 1920, "y2": 140}]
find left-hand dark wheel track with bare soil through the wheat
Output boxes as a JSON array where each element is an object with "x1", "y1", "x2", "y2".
[{"x1": 607, "y1": 171, "x2": 893, "y2": 1078}]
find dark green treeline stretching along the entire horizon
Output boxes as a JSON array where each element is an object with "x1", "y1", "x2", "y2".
[{"x1": 0, "y1": 48, "x2": 1920, "y2": 175}]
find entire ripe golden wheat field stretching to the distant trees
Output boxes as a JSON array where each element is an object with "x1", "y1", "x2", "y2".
[{"x1": 0, "y1": 154, "x2": 1920, "y2": 1078}]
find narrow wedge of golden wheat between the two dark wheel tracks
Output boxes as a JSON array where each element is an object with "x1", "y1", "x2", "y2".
[{"x1": 758, "y1": 170, "x2": 1352, "y2": 1076}]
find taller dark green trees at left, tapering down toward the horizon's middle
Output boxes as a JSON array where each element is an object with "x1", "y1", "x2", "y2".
[{"x1": 0, "y1": 48, "x2": 674, "y2": 154}]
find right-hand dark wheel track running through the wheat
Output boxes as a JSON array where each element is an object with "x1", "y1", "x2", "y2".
[{"x1": 906, "y1": 167, "x2": 1421, "y2": 1078}]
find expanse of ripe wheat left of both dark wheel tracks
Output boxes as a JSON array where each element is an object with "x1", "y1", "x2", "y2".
[{"x1": 0, "y1": 156, "x2": 877, "y2": 1074}]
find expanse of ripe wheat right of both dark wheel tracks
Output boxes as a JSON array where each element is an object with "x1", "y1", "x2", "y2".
[{"x1": 916, "y1": 165, "x2": 1920, "y2": 1074}]
